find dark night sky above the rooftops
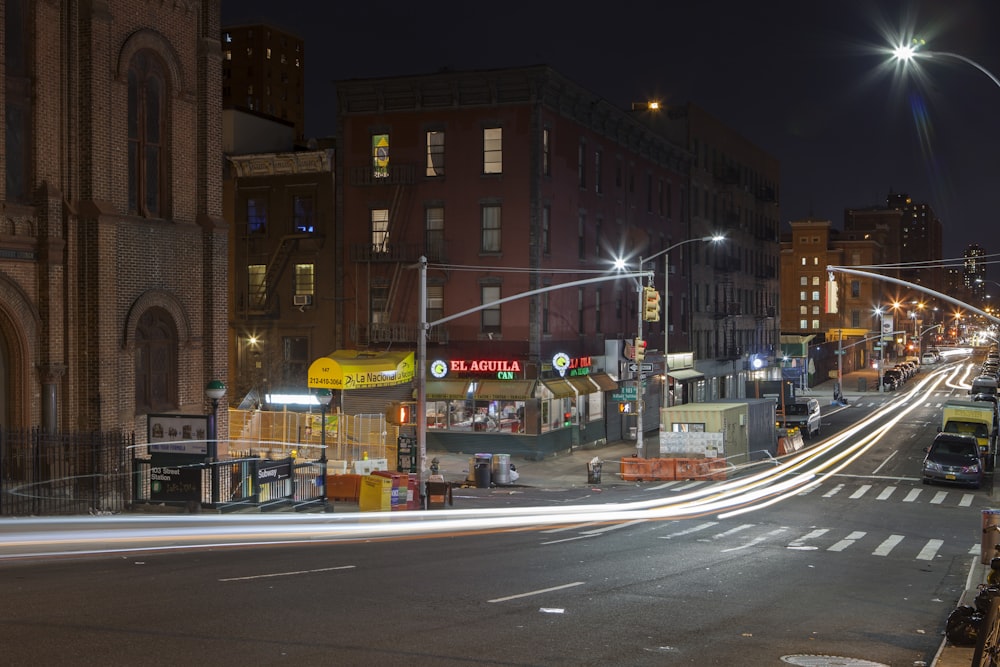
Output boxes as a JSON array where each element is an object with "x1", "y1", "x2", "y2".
[{"x1": 222, "y1": 0, "x2": 1000, "y2": 268}]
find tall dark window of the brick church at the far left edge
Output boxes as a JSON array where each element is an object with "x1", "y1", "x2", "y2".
[{"x1": 3, "y1": 0, "x2": 31, "y2": 203}]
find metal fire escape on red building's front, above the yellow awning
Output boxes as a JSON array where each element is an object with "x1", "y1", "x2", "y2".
[{"x1": 348, "y1": 164, "x2": 447, "y2": 347}]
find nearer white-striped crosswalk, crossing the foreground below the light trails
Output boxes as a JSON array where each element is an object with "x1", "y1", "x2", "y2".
[{"x1": 541, "y1": 521, "x2": 980, "y2": 561}]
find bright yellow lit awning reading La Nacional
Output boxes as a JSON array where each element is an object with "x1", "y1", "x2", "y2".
[{"x1": 308, "y1": 350, "x2": 414, "y2": 390}]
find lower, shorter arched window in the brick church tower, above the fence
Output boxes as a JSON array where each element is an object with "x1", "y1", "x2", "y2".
[{"x1": 135, "y1": 308, "x2": 177, "y2": 415}]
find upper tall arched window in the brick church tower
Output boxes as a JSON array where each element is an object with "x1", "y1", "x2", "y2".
[{"x1": 128, "y1": 51, "x2": 170, "y2": 218}]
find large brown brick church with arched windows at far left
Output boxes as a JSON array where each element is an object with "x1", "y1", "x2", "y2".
[{"x1": 0, "y1": 0, "x2": 227, "y2": 440}]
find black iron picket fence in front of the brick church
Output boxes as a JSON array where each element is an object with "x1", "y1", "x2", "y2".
[{"x1": 0, "y1": 428, "x2": 135, "y2": 516}]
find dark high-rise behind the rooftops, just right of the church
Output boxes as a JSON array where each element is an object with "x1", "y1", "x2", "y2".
[{"x1": 222, "y1": 24, "x2": 305, "y2": 142}]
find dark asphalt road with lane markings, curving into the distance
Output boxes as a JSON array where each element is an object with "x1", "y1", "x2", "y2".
[{"x1": 0, "y1": 366, "x2": 990, "y2": 666}]
